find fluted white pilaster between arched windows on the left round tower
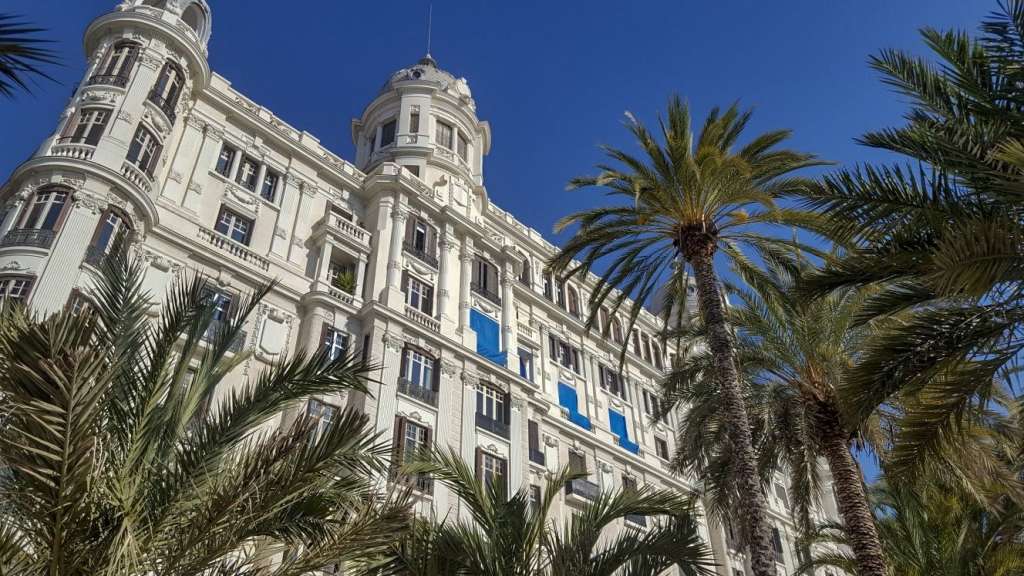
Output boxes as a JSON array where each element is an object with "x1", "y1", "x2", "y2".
[{"x1": 31, "y1": 190, "x2": 106, "y2": 315}]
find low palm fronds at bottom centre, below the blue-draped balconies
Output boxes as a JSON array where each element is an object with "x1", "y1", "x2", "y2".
[{"x1": 368, "y1": 451, "x2": 714, "y2": 576}]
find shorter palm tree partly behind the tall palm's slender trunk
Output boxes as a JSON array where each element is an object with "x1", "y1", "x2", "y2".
[{"x1": 662, "y1": 251, "x2": 886, "y2": 576}]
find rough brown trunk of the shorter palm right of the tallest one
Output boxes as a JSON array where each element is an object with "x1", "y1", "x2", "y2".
[{"x1": 821, "y1": 420, "x2": 887, "y2": 576}]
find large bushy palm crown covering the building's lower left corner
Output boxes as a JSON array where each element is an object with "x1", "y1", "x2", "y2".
[{"x1": 0, "y1": 254, "x2": 408, "y2": 576}]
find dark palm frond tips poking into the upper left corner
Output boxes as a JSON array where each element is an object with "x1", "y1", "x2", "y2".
[{"x1": 0, "y1": 13, "x2": 58, "y2": 97}]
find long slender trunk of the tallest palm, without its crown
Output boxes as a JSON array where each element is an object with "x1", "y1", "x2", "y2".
[{"x1": 687, "y1": 250, "x2": 775, "y2": 576}]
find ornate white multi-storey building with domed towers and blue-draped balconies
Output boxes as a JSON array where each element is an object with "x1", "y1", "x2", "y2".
[{"x1": 0, "y1": 0, "x2": 835, "y2": 576}]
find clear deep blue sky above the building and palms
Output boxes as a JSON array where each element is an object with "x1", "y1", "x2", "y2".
[{"x1": 0, "y1": 0, "x2": 995, "y2": 479}]
